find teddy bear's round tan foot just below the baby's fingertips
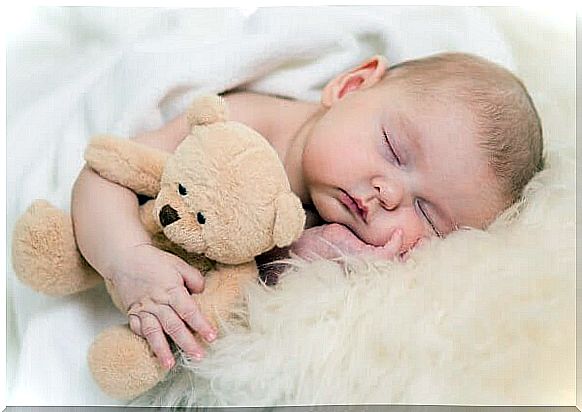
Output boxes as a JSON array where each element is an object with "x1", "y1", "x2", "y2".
[{"x1": 88, "y1": 325, "x2": 167, "y2": 400}]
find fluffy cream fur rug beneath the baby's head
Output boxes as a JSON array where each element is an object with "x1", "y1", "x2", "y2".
[{"x1": 138, "y1": 8, "x2": 575, "y2": 405}]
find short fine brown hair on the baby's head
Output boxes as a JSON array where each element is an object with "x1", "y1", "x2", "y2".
[{"x1": 384, "y1": 53, "x2": 544, "y2": 205}]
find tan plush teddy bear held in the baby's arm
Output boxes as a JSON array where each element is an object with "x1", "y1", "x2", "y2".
[{"x1": 12, "y1": 96, "x2": 305, "y2": 400}]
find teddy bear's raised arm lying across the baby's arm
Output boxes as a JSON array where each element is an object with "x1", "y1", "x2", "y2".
[{"x1": 85, "y1": 136, "x2": 170, "y2": 197}]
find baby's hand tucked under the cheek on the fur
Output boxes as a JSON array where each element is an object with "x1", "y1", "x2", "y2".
[{"x1": 291, "y1": 223, "x2": 407, "y2": 260}]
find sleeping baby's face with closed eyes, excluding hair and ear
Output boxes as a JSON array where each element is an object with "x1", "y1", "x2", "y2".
[{"x1": 302, "y1": 79, "x2": 503, "y2": 251}]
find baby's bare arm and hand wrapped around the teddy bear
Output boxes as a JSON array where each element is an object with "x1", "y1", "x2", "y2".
[{"x1": 71, "y1": 115, "x2": 216, "y2": 367}]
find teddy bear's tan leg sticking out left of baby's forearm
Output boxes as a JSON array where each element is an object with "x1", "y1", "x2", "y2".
[{"x1": 12, "y1": 200, "x2": 102, "y2": 296}]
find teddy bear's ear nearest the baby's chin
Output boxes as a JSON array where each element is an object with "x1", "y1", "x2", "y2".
[{"x1": 273, "y1": 192, "x2": 305, "y2": 247}]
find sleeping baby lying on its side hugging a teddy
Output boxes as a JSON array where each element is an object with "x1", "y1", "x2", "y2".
[{"x1": 72, "y1": 53, "x2": 543, "y2": 368}]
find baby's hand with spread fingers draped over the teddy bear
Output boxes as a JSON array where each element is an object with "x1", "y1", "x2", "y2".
[{"x1": 109, "y1": 244, "x2": 217, "y2": 369}]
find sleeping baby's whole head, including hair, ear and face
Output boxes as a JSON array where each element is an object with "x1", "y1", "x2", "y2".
[{"x1": 303, "y1": 53, "x2": 543, "y2": 249}]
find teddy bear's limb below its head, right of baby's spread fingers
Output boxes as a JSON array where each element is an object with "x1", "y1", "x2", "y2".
[{"x1": 192, "y1": 261, "x2": 259, "y2": 327}]
